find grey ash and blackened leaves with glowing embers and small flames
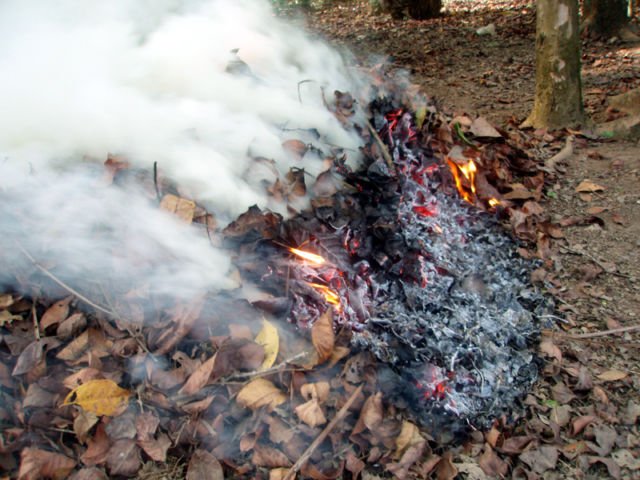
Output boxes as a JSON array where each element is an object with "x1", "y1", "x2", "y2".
[{"x1": 230, "y1": 85, "x2": 546, "y2": 441}]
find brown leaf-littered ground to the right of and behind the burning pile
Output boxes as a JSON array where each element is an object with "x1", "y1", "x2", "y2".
[{"x1": 306, "y1": 0, "x2": 640, "y2": 478}]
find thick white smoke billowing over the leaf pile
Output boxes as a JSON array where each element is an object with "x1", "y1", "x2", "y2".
[{"x1": 0, "y1": 0, "x2": 359, "y2": 297}]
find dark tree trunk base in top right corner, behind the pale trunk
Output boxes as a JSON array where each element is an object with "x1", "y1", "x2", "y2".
[{"x1": 582, "y1": 0, "x2": 629, "y2": 38}]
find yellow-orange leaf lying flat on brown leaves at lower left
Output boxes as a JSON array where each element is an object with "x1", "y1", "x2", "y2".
[{"x1": 63, "y1": 379, "x2": 131, "y2": 416}]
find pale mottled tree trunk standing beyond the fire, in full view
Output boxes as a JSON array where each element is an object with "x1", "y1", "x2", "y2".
[{"x1": 523, "y1": 0, "x2": 585, "y2": 128}]
